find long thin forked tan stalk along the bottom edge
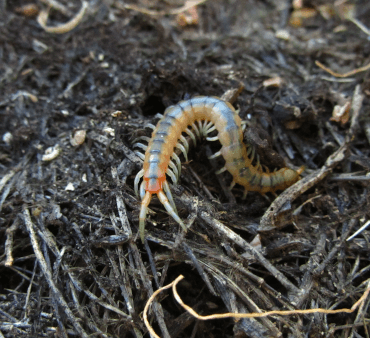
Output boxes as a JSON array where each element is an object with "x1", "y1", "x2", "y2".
[{"x1": 143, "y1": 275, "x2": 370, "y2": 338}]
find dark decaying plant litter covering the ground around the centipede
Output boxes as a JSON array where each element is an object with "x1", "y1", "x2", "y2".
[{"x1": 0, "y1": 0, "x2": 370, "y2": 337}]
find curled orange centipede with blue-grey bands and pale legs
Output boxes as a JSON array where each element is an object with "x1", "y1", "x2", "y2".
[{"x1": 133, "y1": 96, "x2": 304, "y2": 242}]
